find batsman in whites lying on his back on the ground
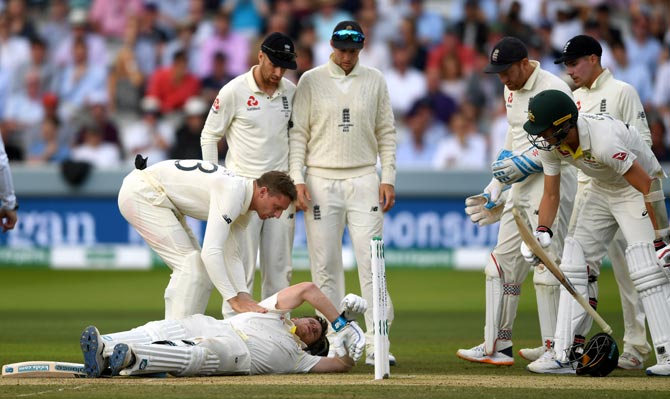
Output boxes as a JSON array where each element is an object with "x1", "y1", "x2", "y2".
[{"x1": 80, "y1": 282, "x2": 367, "y2": 378}]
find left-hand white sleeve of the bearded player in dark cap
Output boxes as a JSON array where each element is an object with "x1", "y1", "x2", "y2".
[{"x1": 200, "y1": 86, "x2": 235, "y2": 164}]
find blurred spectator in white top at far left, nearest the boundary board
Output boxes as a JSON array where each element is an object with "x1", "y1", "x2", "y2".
[{"x1": 70, "y1": 121, "x2": 121, "y2": 169}]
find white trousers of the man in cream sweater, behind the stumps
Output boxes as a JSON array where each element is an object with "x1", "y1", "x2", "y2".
[{"x1": 305, "y1": 171, "x2": 393, "y2": 353}]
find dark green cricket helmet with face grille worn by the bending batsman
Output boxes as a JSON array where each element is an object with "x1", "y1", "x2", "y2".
[{"x1": 523, "y1": 90, "x2": 579, "y2": 151}]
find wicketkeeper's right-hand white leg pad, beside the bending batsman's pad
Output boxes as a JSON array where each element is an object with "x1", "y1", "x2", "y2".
[{"x1": 533, "y1": 264, "x2": 561, "y2": 345}]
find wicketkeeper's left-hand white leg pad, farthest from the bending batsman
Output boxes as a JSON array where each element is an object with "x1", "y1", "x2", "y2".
[{"x1": 484, "y1": 254, "x2": 521, "y2": 355}]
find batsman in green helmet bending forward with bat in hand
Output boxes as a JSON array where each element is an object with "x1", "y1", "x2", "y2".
[{"x1": 521, "y1": 90, "x2": 670, "y2": 376}]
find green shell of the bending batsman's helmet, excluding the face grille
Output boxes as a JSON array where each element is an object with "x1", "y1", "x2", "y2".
[{"x1": 523, "y1": 90, "x2": 579, "y2": 136}]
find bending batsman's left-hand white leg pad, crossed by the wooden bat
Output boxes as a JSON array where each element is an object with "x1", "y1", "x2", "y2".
[{"x1": 554, "y1": 237, "x2": 588, "y2": 362}]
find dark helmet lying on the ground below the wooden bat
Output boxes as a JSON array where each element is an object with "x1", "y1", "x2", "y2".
[{"x1": 575, "y1": 333, "x2": 619, "y2": 377}]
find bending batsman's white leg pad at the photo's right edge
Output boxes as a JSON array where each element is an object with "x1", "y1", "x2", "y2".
[{"x1": 626, "y1": 243, "x2": 670, "y2": 357}]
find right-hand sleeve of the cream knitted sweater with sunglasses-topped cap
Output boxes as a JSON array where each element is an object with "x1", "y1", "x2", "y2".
[{"x1": 375, "y1": 74, "x2": 396, "y2": 186}]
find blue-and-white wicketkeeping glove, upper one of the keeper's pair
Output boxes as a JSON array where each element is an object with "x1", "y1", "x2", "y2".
[{"x1": 491, "y1": 146, "x2": 542, "y2": 184}]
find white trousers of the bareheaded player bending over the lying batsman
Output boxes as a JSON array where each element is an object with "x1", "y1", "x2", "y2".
[{"x1": 118, "y1": 169, "x2": 213, "y2": 320}]
